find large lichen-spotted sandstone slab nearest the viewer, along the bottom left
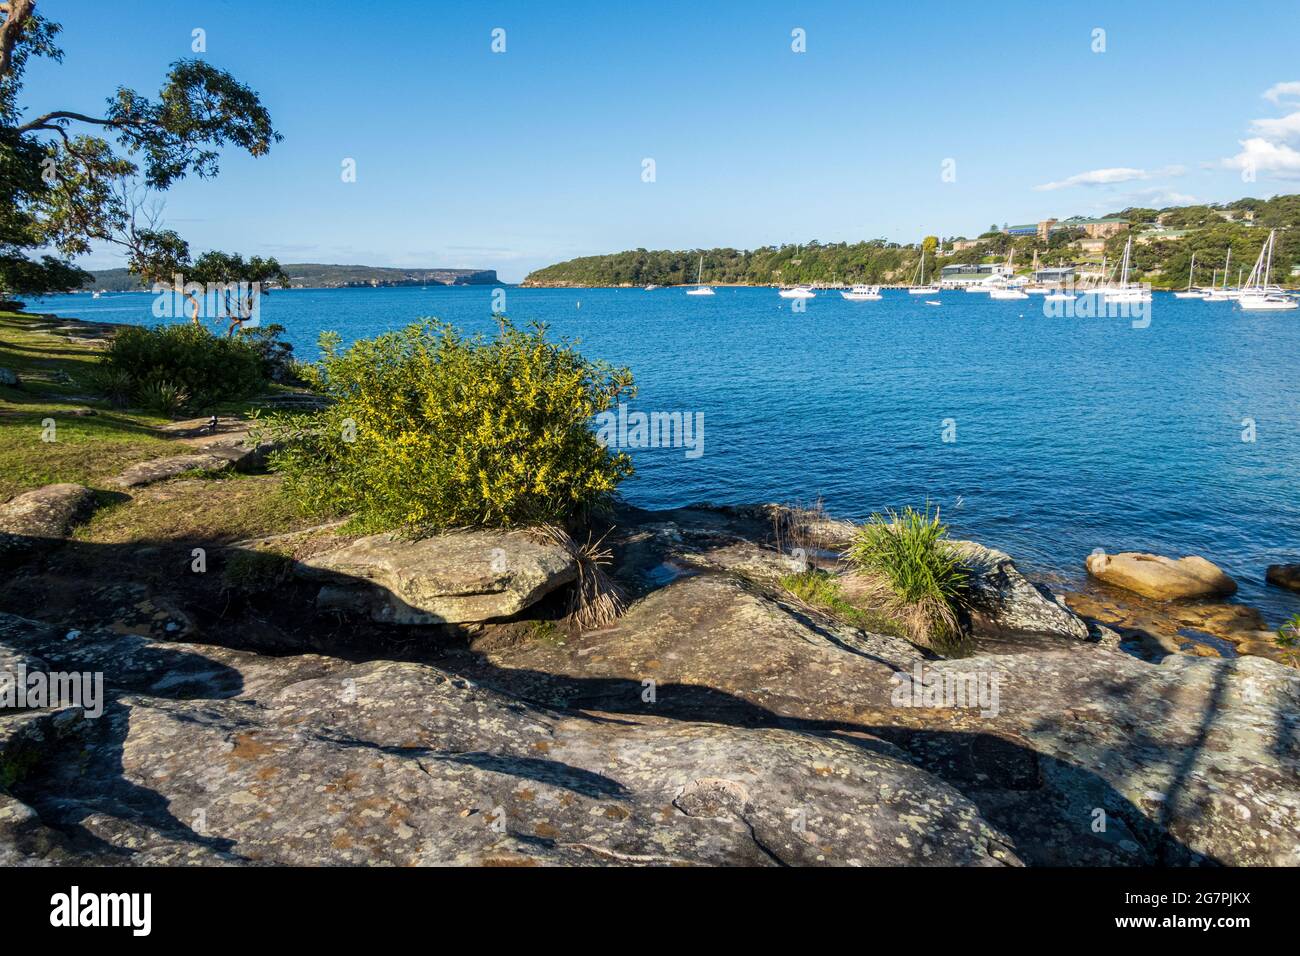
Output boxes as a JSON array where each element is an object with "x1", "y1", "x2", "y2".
[{"x1": 0, "y1": 615, "x2": 1019, "y2": 866}]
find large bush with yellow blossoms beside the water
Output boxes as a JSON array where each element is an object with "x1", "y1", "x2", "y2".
[{"x1": 269, "y1": 320, "x2": 633, "y2": 532}]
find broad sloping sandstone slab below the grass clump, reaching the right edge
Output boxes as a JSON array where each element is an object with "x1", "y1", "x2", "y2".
[{"x1": 488, "y1": 574, "x2": 1300, "y2": 865}]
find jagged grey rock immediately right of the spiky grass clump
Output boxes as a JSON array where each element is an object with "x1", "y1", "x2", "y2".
[{"x1": 953, "y1": 541, "x2": 1088, "y2": 640}]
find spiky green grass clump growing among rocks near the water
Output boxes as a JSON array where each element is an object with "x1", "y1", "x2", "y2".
[{"x1": 845, "y1": 505, "x2": 970, "y2": 652}]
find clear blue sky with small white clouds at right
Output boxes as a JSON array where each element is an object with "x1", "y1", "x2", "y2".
[{"x1": 23, "y1": 0, "x2": 1300, "y2": 281}]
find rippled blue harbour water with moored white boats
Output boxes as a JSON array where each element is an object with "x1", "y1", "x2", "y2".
[{"x1": 30, "y1": 287, "x2": 1300, "y2": 623}]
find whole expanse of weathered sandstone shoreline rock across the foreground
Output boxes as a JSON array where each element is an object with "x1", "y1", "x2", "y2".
[{"x1": 0, "y1": 496, "x2": 1300, "y2": 866}]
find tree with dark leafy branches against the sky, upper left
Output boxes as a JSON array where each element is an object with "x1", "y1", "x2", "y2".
[{"x1": 0, "y1": 0, "x2": 281, "y2": 294}]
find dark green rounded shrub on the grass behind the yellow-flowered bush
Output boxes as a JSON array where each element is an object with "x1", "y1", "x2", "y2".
[{"x1": 92, "y1": 325, "x2": 275, "y2": 414}]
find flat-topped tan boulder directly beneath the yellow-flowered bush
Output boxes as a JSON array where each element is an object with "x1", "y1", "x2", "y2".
[{"x1": 295, "y1": 531, "x2": 577, "y2": 624}]
